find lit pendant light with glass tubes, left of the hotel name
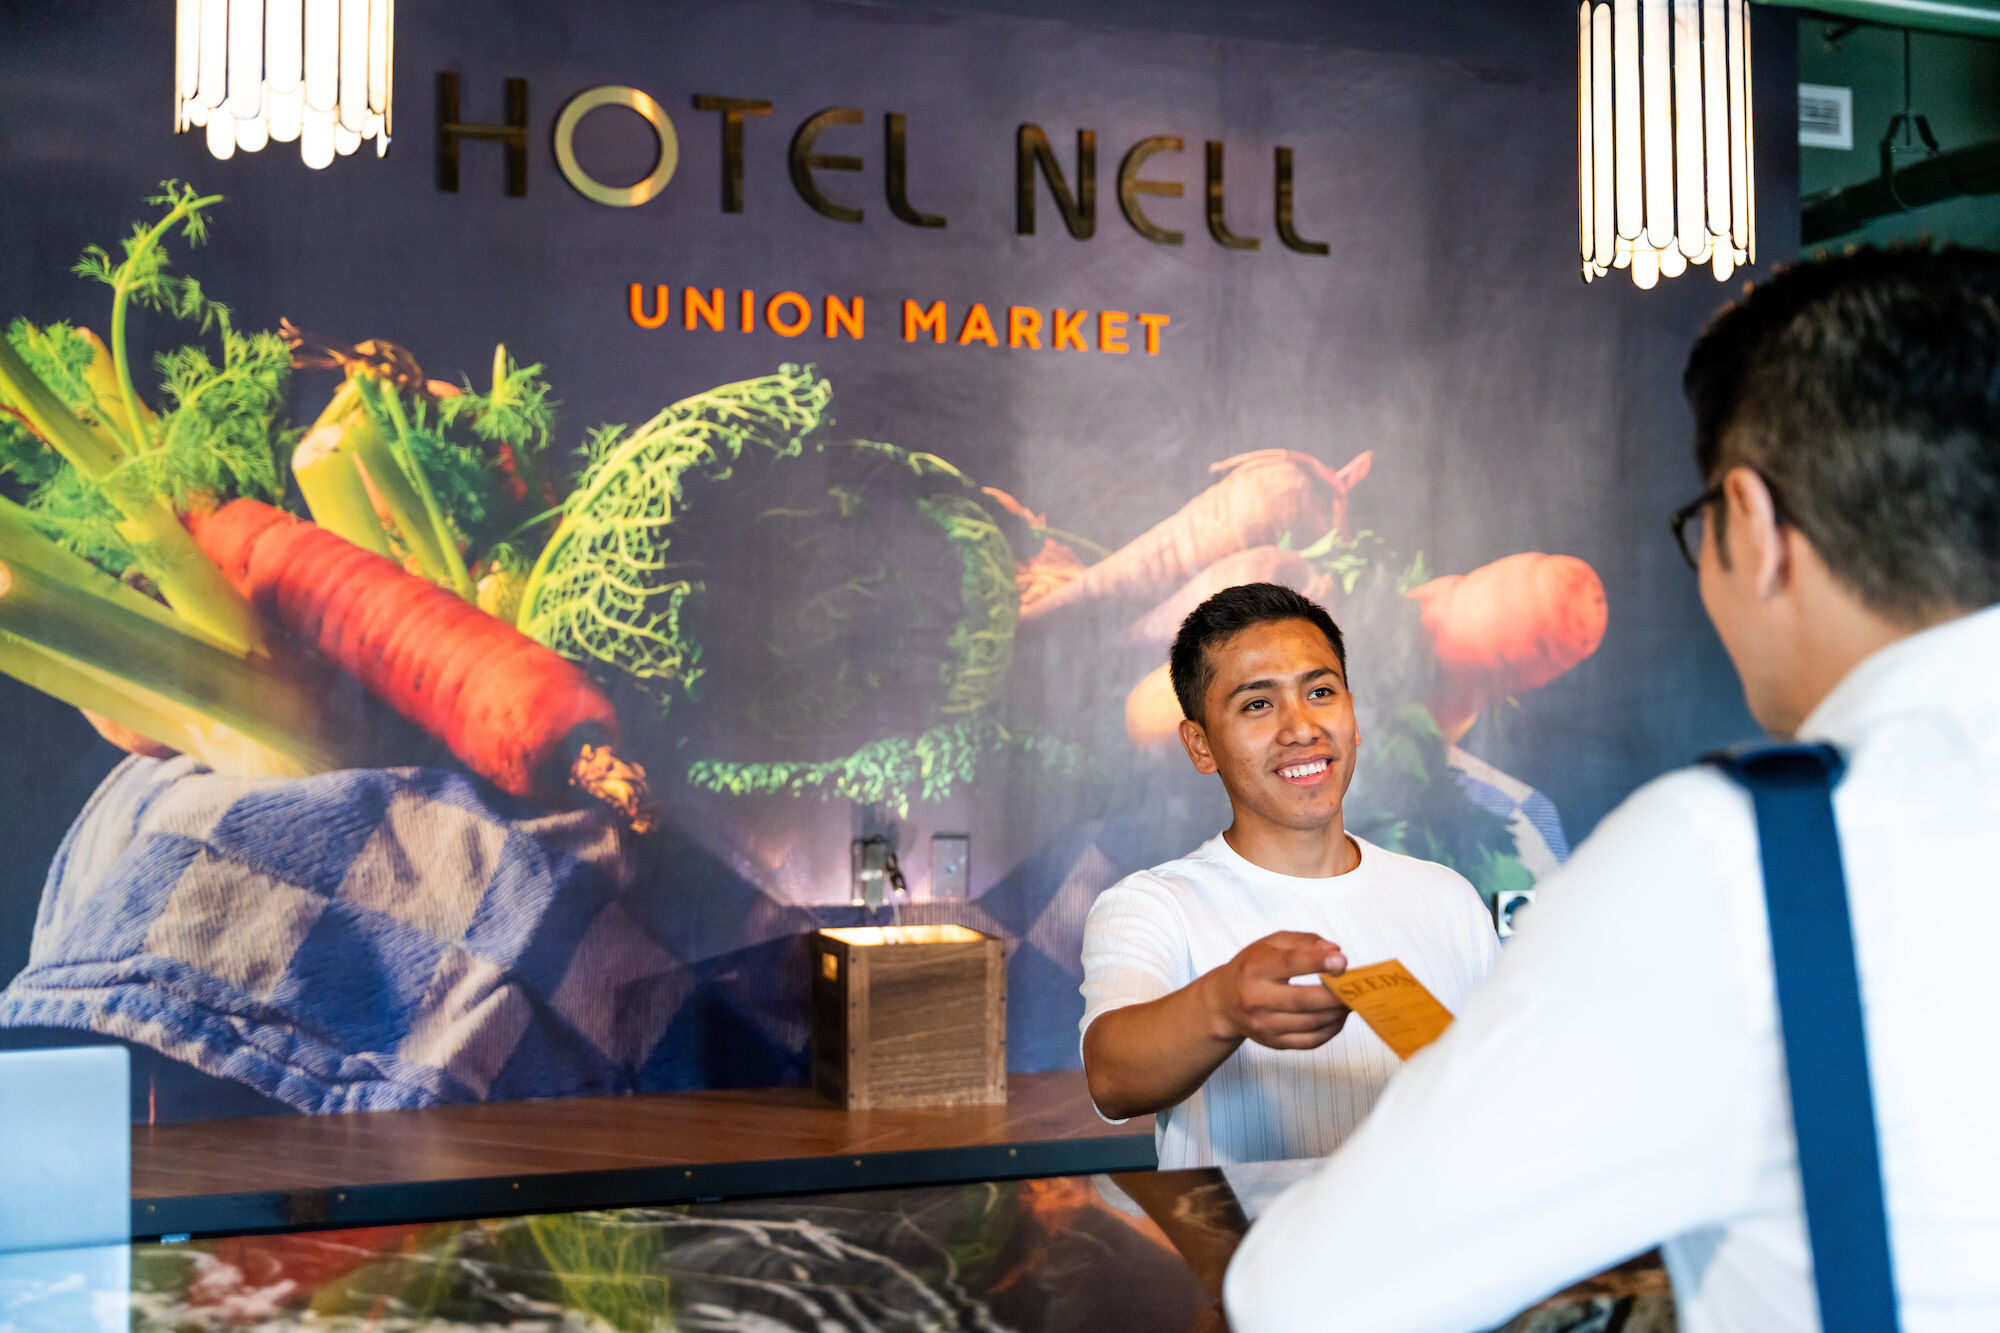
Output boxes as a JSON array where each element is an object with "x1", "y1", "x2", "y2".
[{"x1": 174, "y1": 0, "x2": 396, "y2": 168}]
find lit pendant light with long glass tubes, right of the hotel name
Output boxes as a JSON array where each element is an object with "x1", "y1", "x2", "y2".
[{"x1": 1576, "y1": 0, "x2": 1756, "y2": 286}]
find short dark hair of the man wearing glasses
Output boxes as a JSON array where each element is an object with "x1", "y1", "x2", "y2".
[{"x1": 1682, "y1": 246, "x2": 2000, "y2": 624}]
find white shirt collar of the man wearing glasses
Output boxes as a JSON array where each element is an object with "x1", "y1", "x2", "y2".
[{"x1": 1798, "y1": 604, "x2": 2000, "y2": 747}]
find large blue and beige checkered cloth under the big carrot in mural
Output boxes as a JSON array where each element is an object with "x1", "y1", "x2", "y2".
[{"x1": 0, "y1": 759, "x2": 672, "y2": 1113}]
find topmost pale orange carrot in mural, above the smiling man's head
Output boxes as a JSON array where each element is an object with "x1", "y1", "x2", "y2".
[{"x1": 1020, "y1": 448, "x2": 1374, "y2": 622}]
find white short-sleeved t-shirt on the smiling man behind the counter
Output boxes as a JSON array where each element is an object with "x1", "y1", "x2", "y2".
[{"x1": 1082, "y1": 835, "x2": 1500, "y2": 1169}]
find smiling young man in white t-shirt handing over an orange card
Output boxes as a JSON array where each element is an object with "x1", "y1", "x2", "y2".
[{"x1": 1082, "y1": 582, "x2": 1498, "y2": 1169}]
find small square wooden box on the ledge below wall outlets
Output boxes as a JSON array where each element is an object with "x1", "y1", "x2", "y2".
[{"x1": 812, "y1": 925, "x2": 1006, "y2": 1111}]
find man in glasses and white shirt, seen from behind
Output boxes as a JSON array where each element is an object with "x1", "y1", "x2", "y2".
[{"x1": 1226, "y1": 250, "x2": 2000, "y2": 1333}]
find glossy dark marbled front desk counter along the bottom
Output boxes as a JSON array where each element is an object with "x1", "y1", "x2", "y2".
[{"x1": 0, "y1": 1163, "x2": 1674, "y2": 1333}]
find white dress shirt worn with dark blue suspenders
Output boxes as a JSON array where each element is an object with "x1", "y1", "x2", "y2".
[{"x1": 1226, "y1": 608, "x2": 2000, "y2": 1333}]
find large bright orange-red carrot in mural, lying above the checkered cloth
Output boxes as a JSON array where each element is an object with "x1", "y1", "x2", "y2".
[{"x1": 188, "y1": 498, "x2": 652, "y2": 831}]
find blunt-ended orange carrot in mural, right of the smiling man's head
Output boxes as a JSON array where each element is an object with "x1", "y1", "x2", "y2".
[{"x1": 1410, "y1": 550, "x2": 1606, "y2": 741}]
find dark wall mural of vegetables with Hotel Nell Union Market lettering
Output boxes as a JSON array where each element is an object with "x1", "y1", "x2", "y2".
[{"x1": 0, "y1": 4, "x2": 1734, "y2": 1117}]
